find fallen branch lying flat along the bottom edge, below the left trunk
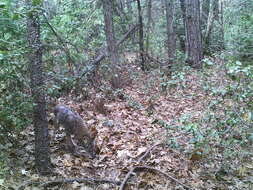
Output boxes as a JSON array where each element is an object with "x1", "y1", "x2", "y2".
[{"x1": 18, "y1": 178, "x2": 121, "y2": 190}]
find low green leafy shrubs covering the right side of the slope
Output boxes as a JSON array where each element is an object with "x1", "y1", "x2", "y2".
[{"x1": 153, "y1": 59, "x2": 253, "y2": 185}]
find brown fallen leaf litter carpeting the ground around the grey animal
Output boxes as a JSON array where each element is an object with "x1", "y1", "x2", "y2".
[{"x1": 5, "y1": 58, "x2": 251, "y2": 190}]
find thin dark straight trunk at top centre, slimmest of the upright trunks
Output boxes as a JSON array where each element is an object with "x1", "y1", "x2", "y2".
[{"x1": 137, "y1": 0, "x2": 145, "y2": 71}]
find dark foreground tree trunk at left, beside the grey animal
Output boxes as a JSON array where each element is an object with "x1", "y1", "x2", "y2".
[{"x1": 27, "y1": 3, "x2": 51, "y2": 175}]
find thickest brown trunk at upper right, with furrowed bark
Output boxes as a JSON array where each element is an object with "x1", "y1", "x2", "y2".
[{"x1": 185, "y1": 0, "x2": 203, "y2": 68}]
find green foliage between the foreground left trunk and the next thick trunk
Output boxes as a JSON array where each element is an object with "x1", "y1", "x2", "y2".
[{"x1": 41, "y1": 0, "x2": 105, "y2": 98}]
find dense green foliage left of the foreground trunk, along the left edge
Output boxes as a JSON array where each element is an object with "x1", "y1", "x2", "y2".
[{"x1": 0, "y1": 0, "x2": 32, "y2": 141}]
